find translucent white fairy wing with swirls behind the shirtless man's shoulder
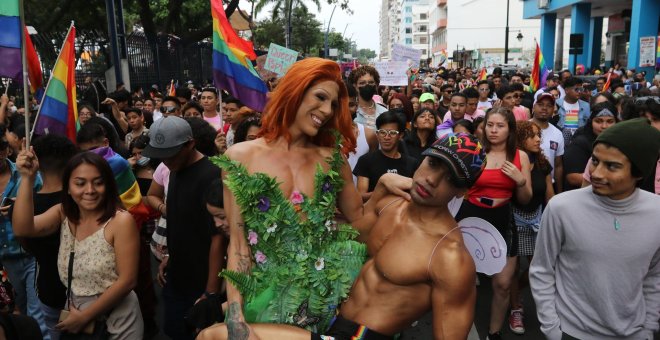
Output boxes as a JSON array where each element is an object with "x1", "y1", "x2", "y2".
[{"x1": 458, "y1": 217, "x2": 507, "y2": 275}]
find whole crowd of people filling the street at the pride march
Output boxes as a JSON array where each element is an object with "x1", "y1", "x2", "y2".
[{"x1": 0, "y1": 58, "x2": 660, "y2": 340}]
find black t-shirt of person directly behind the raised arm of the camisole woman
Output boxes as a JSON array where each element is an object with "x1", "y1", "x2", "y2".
[{"x1": 21, "y1": 191, "x2": 66, "y2": 309}]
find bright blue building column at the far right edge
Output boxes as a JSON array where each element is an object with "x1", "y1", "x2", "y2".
[{"x1": 628, "y1": 0, "x2": 660, "y2": 81}]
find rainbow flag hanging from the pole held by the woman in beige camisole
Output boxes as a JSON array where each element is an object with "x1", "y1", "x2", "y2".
[{"x1": 32, "y1": 23, "x2": 80, "y2": 143}]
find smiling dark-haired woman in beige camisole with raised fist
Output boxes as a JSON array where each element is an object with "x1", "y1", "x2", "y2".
[{"x1": 12, "y1": 150, "x2": 144, "y2": 339}]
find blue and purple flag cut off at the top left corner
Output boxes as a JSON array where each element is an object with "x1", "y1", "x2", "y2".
[{"x1": 0, "y1": 0, "x2": 23, "y2": 84}]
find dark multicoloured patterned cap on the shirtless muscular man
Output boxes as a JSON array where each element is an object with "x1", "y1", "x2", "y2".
[{"x1": 422, "y1": 133, "x2": 486, "y2": 188}]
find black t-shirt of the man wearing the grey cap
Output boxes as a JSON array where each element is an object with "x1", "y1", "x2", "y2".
[{"x1": 167, "y1": 157, "x2": 220, "y2": 294}]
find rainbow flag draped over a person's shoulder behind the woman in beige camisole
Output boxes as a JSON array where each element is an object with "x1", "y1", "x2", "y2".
[{"x1": 91, "y1": 147, "x2": 149, "y2": 228}]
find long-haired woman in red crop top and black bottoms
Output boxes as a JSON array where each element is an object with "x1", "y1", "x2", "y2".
[{"x1": 456, "y1": 107, "x2": 532, "y2": 340}]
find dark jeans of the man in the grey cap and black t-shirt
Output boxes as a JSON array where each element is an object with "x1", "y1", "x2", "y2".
[{"x1": 163, "y1": 281, "x2": 204, "y2": 340}]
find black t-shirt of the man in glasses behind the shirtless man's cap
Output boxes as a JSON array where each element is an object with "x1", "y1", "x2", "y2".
[{"x1": 353, "y1": 150, "x2": 417, "y2": 192}]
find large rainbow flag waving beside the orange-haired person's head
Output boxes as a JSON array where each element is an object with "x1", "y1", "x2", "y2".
[{"x1": 211, "y1": 0, "x2": 268, "y2": 112}]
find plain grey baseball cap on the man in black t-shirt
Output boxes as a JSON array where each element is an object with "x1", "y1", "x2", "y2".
[{"x1": 142, "y1": 116, "x2": 193, "y2": 159}]
